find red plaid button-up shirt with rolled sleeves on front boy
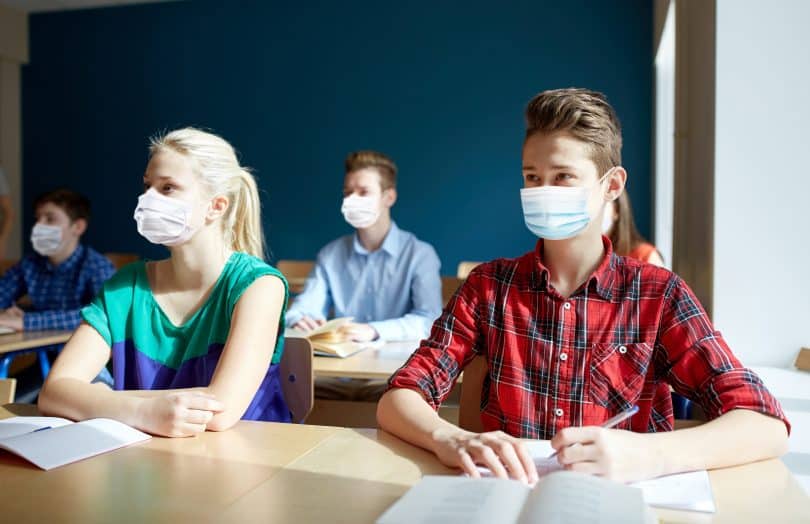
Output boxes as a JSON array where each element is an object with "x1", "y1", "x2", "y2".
[{"x1": 390, "y1": 237, "x2": 790, "y2": 439}]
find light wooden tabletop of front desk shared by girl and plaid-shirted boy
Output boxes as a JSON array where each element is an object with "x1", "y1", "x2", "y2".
[{"x1": 0, "y1": 408, "x2": 810, "y2": 523}]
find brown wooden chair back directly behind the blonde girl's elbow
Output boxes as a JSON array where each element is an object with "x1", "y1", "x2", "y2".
[{"x1": 279, "y1": 337, "x2": 315, "y2": 424}]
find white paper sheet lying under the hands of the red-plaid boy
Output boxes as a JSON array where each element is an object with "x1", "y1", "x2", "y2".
[{"x1": 478, "y1": 440, "x2": 716, "y2": 513}]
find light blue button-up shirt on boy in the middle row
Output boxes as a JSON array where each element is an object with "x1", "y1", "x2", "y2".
[{"x1": 287, "y1": 222, "x2": 442, "y2": 340}]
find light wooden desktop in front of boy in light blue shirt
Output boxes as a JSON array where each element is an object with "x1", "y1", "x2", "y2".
[{"x1": 312, "y1": 340, "x2": 419, "y2": 380}]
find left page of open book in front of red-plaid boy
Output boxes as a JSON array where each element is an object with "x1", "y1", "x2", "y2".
[{"x1": 377, "y1": 475, "x2": 529, "y2": 524}]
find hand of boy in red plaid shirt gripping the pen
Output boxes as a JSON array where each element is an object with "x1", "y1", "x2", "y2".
[{"x1": 551, "y1": 426, "x2": 663, "y2": 482}]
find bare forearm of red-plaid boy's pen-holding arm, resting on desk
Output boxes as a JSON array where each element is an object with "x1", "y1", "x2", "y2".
[{"x1": 647, "y1": 409, "x2": 787, "y2": 475}]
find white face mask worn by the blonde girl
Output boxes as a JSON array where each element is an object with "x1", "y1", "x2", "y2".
[{"x1": 134, "y1": 188, "x2": 199, "y2": 246}]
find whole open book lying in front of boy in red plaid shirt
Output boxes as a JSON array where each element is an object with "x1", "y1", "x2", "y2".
[{"x1": 377, "y1": 471, "x2": 655, "y2": 524}]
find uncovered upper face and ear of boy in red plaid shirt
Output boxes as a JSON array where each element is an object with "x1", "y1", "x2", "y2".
[{"x1": 523, "y1": 132, "x2": 627, "y2": 236}]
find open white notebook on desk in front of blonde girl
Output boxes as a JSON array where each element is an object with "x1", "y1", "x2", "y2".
[{"x1": 0, "y1": 417, "x2": 152, "y2": 470}]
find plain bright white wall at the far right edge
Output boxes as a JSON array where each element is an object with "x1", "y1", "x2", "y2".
[{"x1": 713, "y1": 0, "x2": 810, "y2": 366}]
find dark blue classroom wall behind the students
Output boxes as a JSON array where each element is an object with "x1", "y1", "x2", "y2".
[{"x1": 23, "y1": 0, "x2": 652, "y2": 274}]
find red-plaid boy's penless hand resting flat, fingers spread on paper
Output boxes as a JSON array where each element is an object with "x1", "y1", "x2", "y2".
[{"x1": 433, "y1": 428, "x2": 537, "y2": 484}]
